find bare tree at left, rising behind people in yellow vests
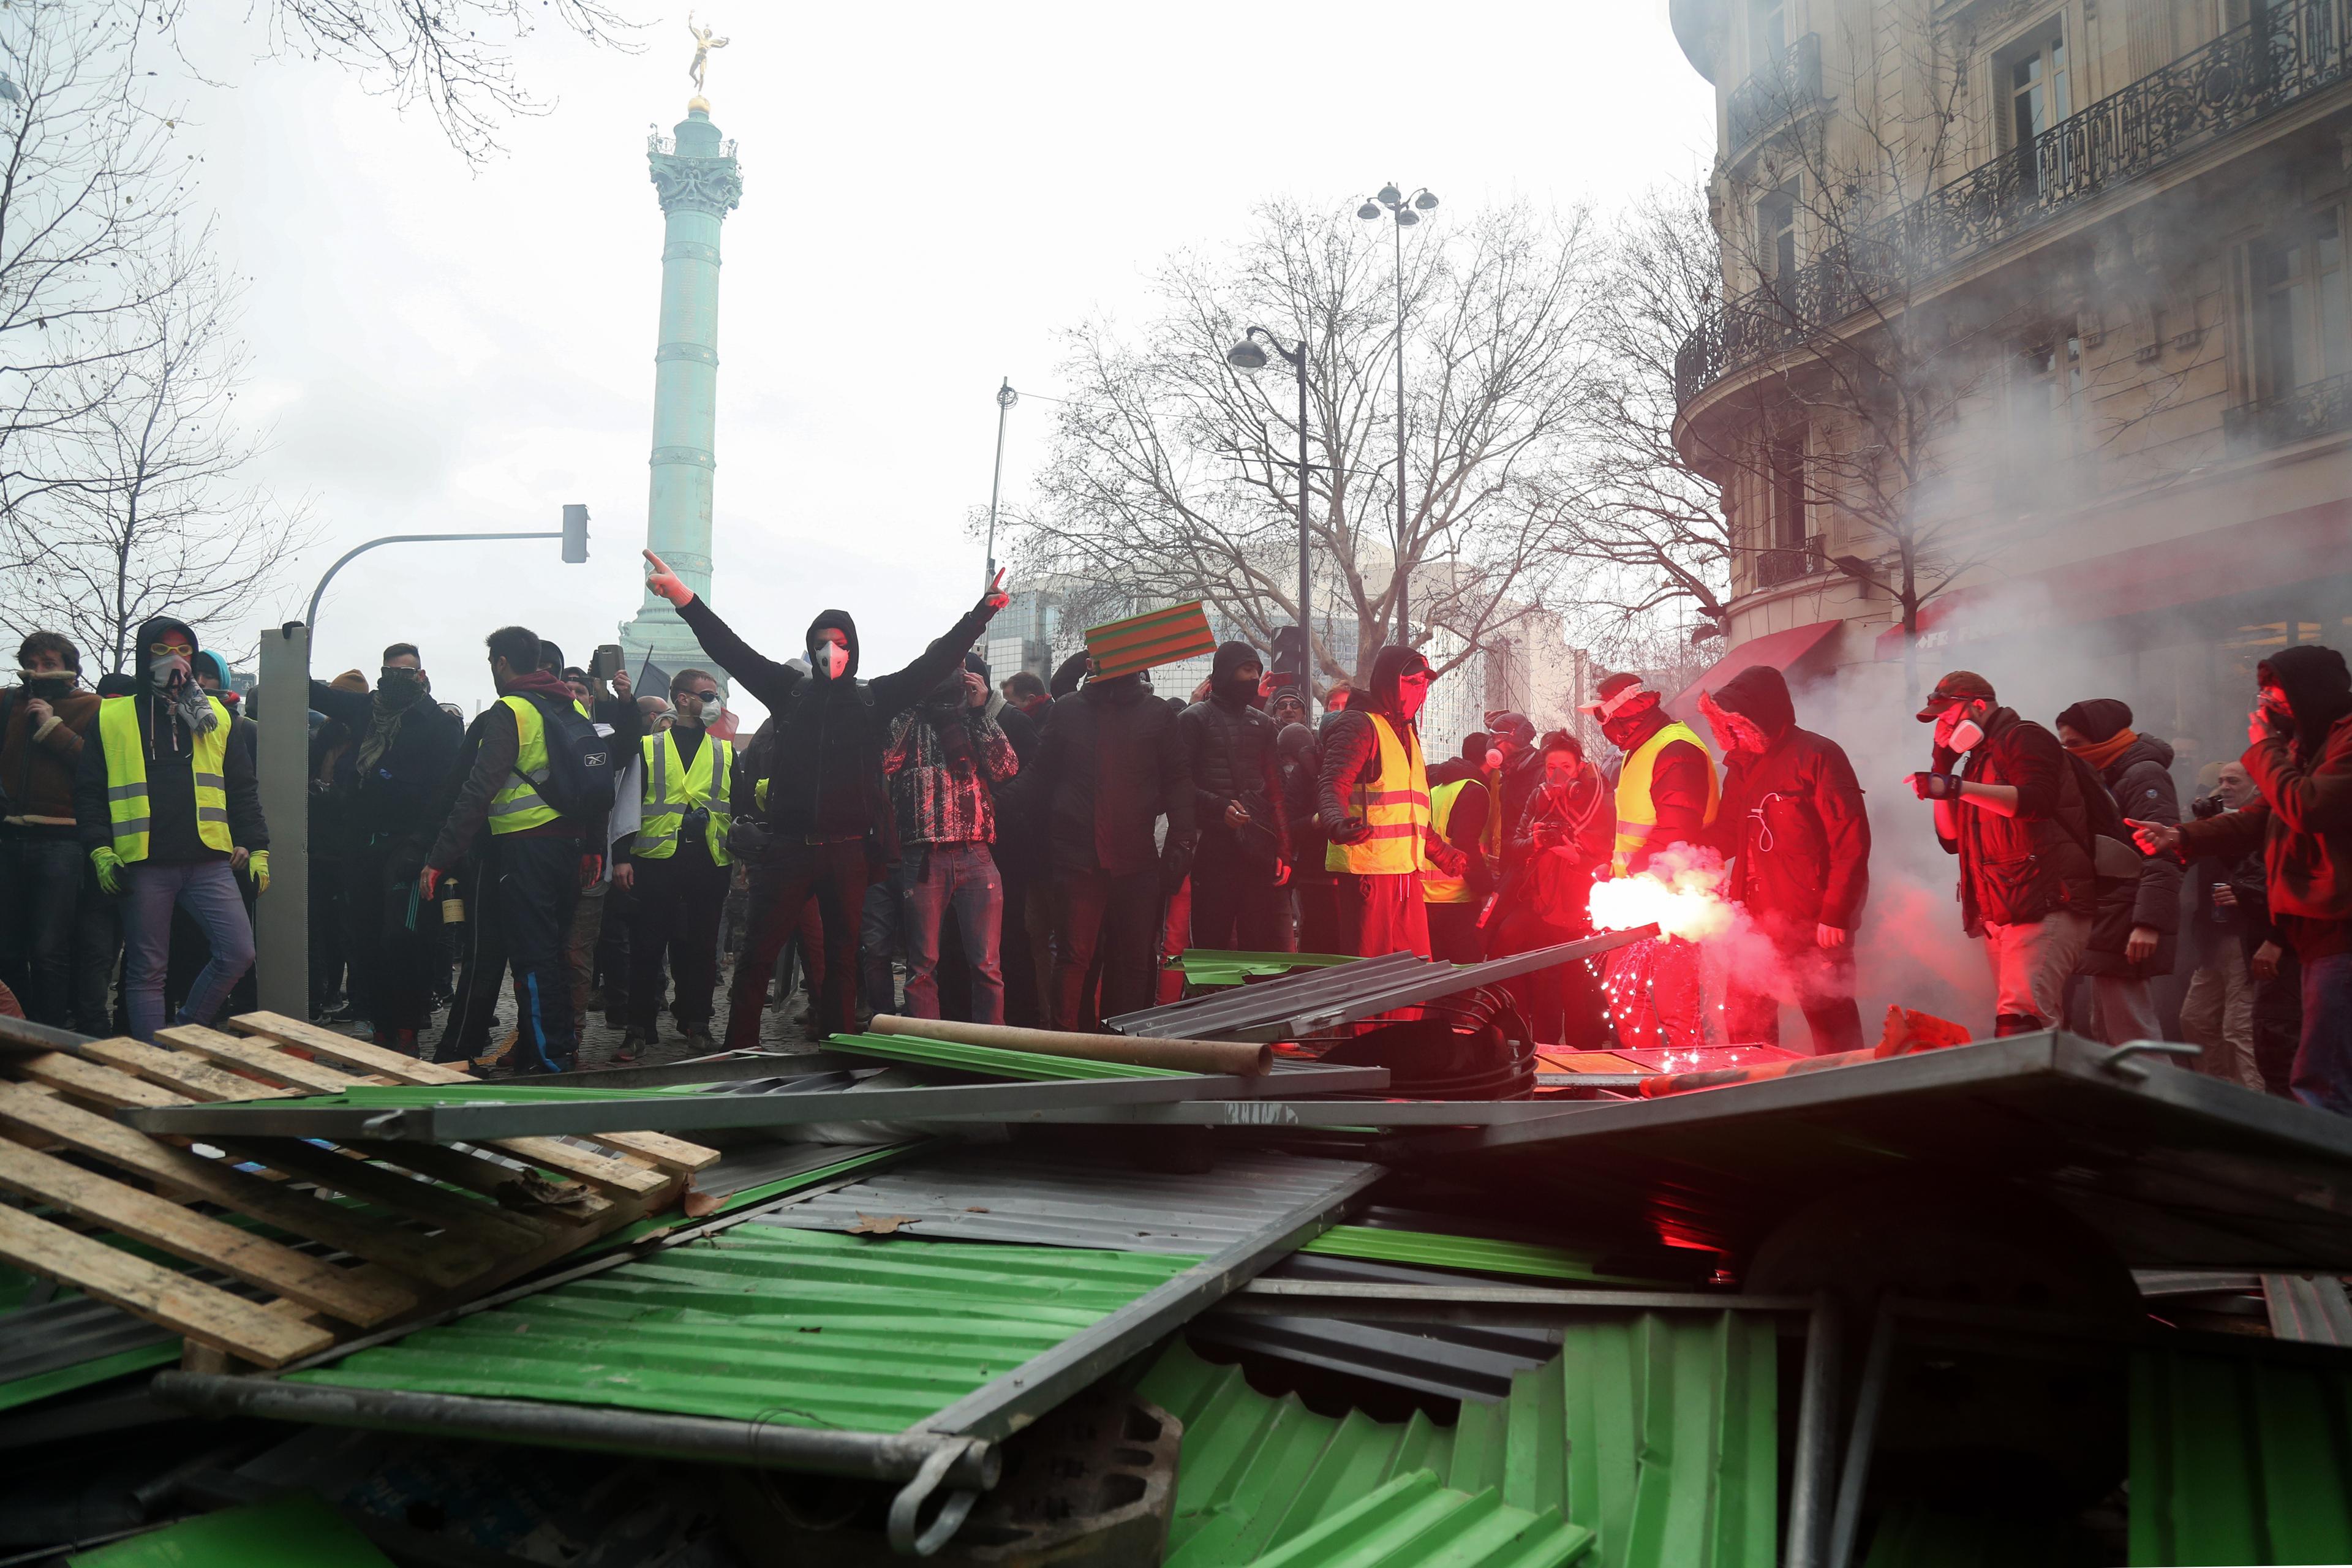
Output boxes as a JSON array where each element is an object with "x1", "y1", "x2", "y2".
[{"x1": 0, "y1": 258, "x2": 311, "y2": 670}]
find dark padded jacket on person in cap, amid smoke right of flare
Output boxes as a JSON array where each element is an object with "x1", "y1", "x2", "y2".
[{"x1": 1943, "y1": 707, "x2": 2098, "y2": 936}]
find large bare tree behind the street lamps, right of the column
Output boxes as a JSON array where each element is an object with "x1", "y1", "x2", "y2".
[{"x1": 1019, "y1": 205, "x2": 1595, "y2": 677}]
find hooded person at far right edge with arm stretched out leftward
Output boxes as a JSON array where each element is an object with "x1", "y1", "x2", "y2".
[{"x1": 2131, "y1": 644, "x2": 2352, "y2": 1114}]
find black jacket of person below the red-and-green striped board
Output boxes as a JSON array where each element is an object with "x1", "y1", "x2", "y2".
[{"x1": 1014, "y1": 675, "x2": 1197, "y2": 877}]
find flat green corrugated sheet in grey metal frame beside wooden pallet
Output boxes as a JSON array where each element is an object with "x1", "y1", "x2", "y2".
[{"x1": 289, "y1": 1225, "x2": 1195, "y2": 1431}]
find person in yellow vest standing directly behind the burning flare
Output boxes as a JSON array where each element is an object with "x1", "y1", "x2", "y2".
[{"x1": 1580, "y1": 675, "x2": 1722, "y2": 1051}]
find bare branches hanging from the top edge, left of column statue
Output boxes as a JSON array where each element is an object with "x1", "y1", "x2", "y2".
[{"x1": 156, "y1": 0, "x2": 642, "y2": 167}]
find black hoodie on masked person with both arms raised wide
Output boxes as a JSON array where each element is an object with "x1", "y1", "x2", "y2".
[{"x1": 677, "y1": 595, "x2": 995, "y2": 846}]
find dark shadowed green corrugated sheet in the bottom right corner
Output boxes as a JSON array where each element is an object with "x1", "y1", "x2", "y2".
[{"x1": 2128, "y1": 1349, "x2": 2352, "y2": 1563}]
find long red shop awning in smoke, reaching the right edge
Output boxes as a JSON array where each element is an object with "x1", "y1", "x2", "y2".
[{"x1": 1877, "y1": 501, "x2": 2352, "y2": 658}]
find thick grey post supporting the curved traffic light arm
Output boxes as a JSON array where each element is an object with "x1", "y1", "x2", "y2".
[{"x1": 254, "y1": 625, "x2": 310, "y2": 1018}]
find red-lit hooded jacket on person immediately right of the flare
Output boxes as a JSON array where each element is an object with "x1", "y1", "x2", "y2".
[{"x1": 1713, "y1": 665, "x2": 1872, "y2": 940}]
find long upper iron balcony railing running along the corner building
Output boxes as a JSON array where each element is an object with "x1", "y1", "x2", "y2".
[{"x1": 1675, "y1": 0, "x2": 2352, "y2": 404}]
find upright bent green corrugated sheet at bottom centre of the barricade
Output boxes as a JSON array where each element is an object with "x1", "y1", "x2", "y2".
[{"x1": 1140, "y1": 1312, "x2": 1778, "y2": 1568}]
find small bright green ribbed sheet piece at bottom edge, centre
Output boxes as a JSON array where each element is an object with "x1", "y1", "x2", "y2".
[{"x1": 1258, "y1": 1469, "x2": 1593, "y2": 1568}]
